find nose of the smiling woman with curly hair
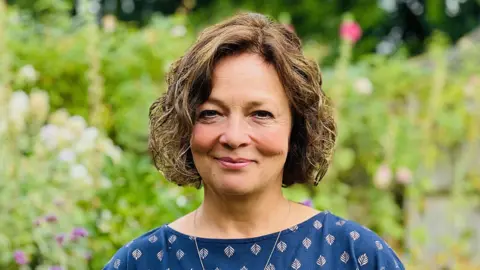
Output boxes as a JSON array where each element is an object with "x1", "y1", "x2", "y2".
[{"x1": 219, "y1": 116, "x2": 251, "y2": 149}]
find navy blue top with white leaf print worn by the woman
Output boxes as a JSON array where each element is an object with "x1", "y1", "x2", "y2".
[{"x1": 103, "y1": 211, "x2": 405, "y2": 270}]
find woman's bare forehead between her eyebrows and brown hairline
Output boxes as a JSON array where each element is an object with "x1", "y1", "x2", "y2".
[{"x1": 210, "y1": 54, "x2": 288, "y2": 106}]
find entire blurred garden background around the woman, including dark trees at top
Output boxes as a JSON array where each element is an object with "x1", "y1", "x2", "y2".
[{"x1": 0, "y1": 0, "x2": 480, "y2": 270}]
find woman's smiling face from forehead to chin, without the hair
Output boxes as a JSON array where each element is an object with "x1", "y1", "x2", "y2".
[{"x1": 190, "y1": 54, "x2": 292, "y2": 195}]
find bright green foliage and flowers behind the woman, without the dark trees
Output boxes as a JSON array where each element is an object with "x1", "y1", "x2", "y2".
[{"x1": 0, "y1": 4, "x2": 480, "y2": 269}]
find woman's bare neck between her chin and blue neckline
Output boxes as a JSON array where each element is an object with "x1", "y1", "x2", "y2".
[{"x1": 195, "y1": 187, "x2": 290, "y2": 239}]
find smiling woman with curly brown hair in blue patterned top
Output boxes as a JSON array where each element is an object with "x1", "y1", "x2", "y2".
[{"x1": 104, "y1": 14, "x2": 404, "y2": 270}]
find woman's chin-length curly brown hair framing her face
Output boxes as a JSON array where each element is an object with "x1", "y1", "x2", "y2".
[{"x1": 148, "y1": 13, "x2": 336, "y2": 187}]
